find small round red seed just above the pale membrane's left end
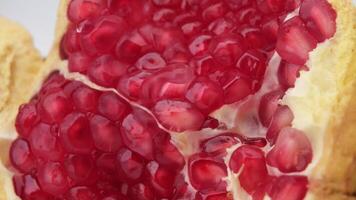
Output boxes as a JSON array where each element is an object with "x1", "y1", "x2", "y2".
[{"x1": 68, "y1": 52, "x2": 92, "y2": 73}]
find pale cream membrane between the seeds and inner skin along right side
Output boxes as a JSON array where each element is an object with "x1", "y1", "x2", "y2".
[{"x1": 0, "y1": 0, "x2": 353, "y2": 200}]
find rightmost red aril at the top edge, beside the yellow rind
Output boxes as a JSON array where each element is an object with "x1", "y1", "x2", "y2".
[{"x1": 299, "y1": 0, "x2": 336, "y2": 42}]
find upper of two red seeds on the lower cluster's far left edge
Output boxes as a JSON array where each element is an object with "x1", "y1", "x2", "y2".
[{"x1": 15, "y1": 104, "x2": 39, "y2": 137}]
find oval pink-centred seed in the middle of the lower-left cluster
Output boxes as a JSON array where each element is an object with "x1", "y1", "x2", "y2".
[{"x1": 90, "y1": 115, "x2": 122, "y2": 152}]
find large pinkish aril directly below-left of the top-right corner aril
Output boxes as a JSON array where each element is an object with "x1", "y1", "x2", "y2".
[{"x1": 276, "y1": 17, "x2": 317, "y2": 65}]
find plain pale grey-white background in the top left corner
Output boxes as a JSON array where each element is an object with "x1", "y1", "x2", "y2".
[{"x1": 0, "y1": 0, "x2": 356, "y2": 55}]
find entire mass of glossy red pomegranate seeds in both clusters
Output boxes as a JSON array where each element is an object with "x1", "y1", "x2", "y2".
[{"x1": 10, "y1": 0, "x2": 336, "y2": 200}]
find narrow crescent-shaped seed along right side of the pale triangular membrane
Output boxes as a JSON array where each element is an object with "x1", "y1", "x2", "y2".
[{"x1": 258, "y1": 90, "x2": 283, "y2": 127}]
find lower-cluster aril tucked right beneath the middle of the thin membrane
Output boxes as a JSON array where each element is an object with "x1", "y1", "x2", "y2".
[{"x1": 121, "y1": 114, "x2": 154, "y2": 160}]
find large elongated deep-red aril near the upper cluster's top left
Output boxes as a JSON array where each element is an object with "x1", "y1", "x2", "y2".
[{"x1": 81, "y1": 15, "x2": 127, "y2": 55}]
